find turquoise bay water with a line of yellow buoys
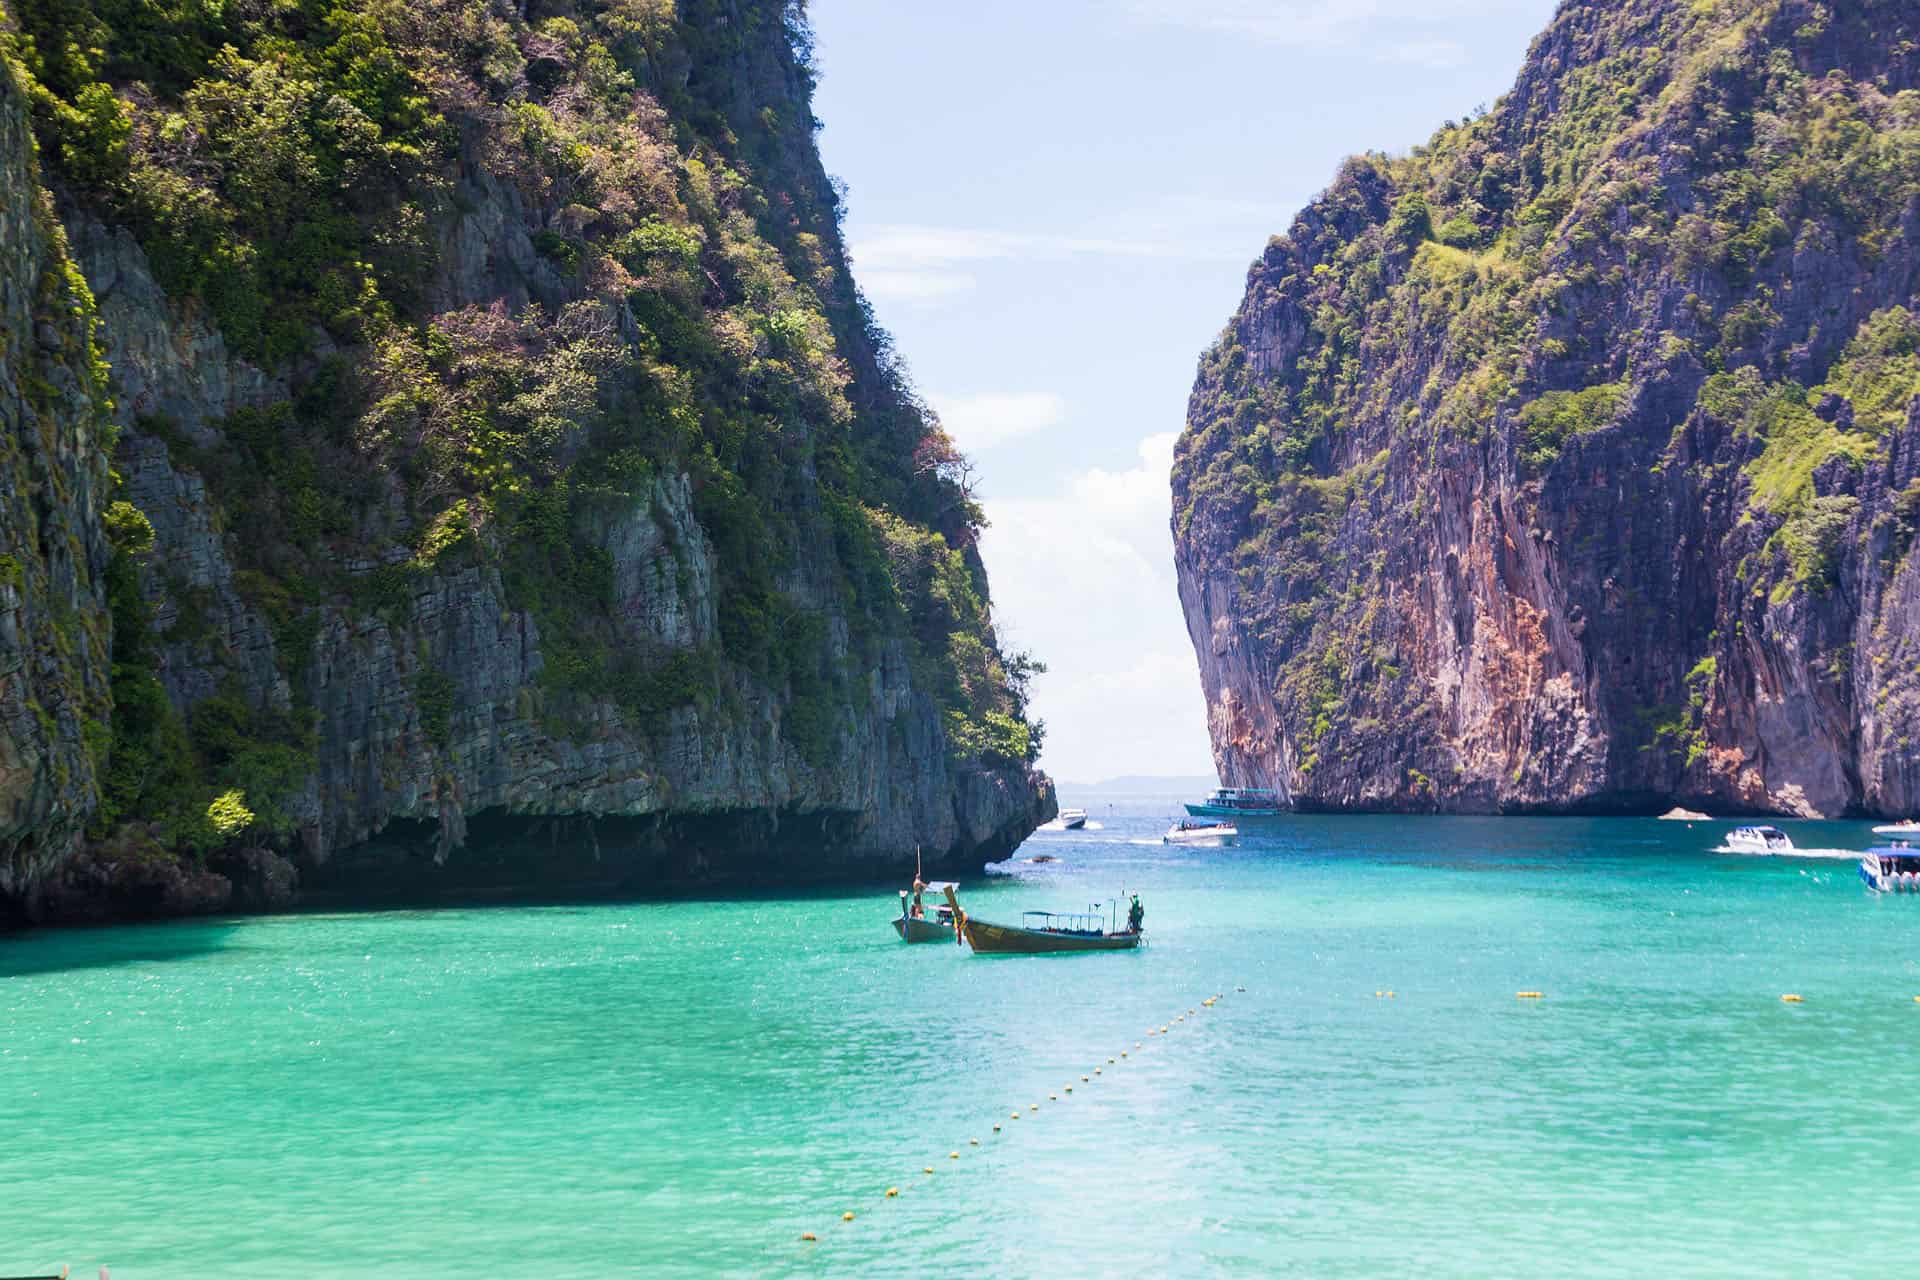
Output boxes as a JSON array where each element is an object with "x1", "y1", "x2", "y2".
[{"x1": 0, "y1": 796, "x2": 1920, "y2": 1280}]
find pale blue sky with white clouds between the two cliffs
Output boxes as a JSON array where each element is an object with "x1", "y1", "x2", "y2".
[{"x1": 810, "y1": 0, "x2": 1553, "y2": 781}]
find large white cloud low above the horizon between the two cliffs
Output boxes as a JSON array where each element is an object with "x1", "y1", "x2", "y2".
[{"x1": 981, "y1": 432, "x2": 1212, "y2": 779}]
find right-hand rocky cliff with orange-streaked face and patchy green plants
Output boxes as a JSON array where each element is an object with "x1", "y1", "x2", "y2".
[{"x1": 1173, "y1": 0, "x2": 1920, "y2": 816}]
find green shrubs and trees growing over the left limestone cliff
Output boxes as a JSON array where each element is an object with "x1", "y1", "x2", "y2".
[{"x1": 0, "y1": 0, "x2": 1039, "y2": 882}]
